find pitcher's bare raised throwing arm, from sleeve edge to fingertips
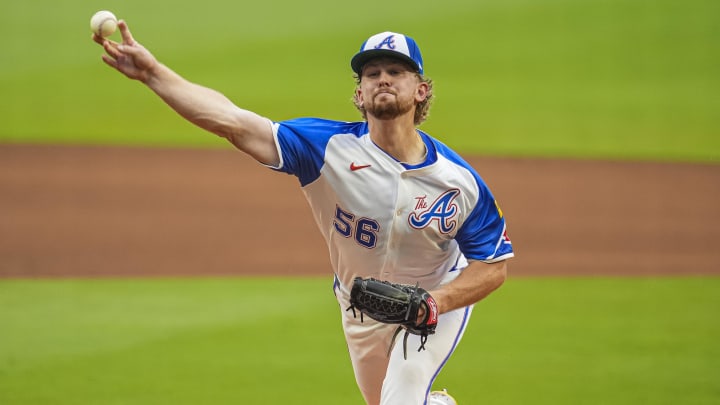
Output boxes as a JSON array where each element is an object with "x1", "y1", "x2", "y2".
[{"x1": 93, "y1": 21, "x2": 280, "y2": 166}]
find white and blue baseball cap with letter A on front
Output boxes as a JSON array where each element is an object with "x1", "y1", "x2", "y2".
[{"x1": 350, "y1": 31, "x2": 423, "y2": 74}]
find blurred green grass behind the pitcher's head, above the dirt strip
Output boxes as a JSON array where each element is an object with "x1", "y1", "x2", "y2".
[{"x1": 0, "y1": 0, "x2": 720, "y2": 162}]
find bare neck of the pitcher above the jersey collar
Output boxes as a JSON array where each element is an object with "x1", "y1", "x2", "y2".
[{"x1": 368, "y1": 120, "x2": 427, "y2": 164}]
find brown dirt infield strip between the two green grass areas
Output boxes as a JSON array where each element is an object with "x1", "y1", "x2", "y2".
[{"x1": 0, "y1": 145, "x2": 720, "y2": 277}]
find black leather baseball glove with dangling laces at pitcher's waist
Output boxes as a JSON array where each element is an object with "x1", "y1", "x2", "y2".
[{"x1": 347, "y1": 277, "x2": 438, "y2": 359}]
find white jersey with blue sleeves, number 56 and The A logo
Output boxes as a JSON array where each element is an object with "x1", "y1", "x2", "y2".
[{"x1": 273, "y1": 118, "x2": 513, "y2": 289}]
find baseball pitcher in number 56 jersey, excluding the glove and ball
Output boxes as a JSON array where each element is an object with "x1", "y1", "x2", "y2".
[{"x1": 94, "y1": 21, "x2": 513, "y2": 405}]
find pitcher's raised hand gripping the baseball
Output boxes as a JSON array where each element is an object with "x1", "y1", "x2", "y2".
[{"x1": 93, "y1": 20, "x2": 158, "y2": 81}]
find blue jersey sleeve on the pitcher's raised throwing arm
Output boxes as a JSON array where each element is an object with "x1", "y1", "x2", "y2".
[{"x1": 276, "y1": 118, "x2": 364, "y2": 186}]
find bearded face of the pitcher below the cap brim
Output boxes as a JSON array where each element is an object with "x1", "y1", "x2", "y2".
[{"x1": 357, "y1": 58, "x2": 427, "y2": 120}]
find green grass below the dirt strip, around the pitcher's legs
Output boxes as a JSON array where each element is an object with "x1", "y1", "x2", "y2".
[{"x1": 0, "y1": 278, "x2": 720, "y2": 405}]
